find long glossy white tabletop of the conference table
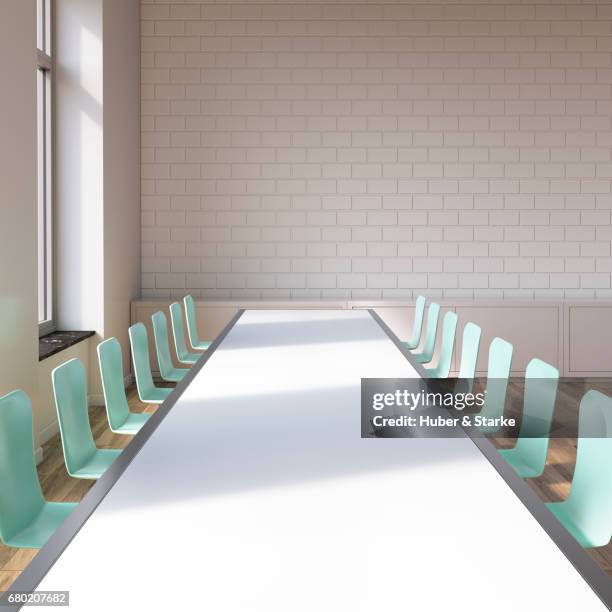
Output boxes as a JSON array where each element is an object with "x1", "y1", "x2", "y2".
[{"x1": 11, "y1": 310, "x2": 607, "y2": 612}]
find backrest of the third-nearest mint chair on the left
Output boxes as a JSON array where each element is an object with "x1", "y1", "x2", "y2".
[{"x1": 98, "y1": 338, "x2": 130, "y2": 429}]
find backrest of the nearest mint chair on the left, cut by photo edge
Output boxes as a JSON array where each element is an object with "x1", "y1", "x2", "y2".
[{"x1": 0, "y1": 390, "x2": 45, "y2": 541}]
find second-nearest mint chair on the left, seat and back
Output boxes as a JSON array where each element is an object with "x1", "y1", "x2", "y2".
[{"x1": 51, "y1": 359, "x2": 121, "y2": 480}]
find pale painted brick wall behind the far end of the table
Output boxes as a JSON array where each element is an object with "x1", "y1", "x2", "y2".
[{"x1": 141, "y1": 0, "x2": 612, "y2": 299}]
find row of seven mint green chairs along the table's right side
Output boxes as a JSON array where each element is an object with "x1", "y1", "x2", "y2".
[{"x1": 404, "y1": 296, "x2": 612, "y2": 548}]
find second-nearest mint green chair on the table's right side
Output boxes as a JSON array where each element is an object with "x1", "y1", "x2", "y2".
[{"x1": 499, "y1": 359, "x2": 559, "y2": 478}]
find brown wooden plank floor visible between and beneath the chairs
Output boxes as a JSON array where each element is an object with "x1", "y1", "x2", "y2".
[{"x1": 0, "y1": 379, "x2": 612, "y2": 591}]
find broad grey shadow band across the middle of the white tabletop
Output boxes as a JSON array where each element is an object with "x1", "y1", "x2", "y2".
[{"x1": 105, "y1": 387, "x2": 482, "y2": 511}]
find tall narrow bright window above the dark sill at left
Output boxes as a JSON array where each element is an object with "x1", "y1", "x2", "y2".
[{"x1": 36, "y1": 0, "x2": 55, "y2": 335}]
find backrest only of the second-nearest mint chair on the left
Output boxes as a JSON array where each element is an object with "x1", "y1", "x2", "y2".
[{"x1": 51, "y1": 359, "x2": 96, "y2": 474}]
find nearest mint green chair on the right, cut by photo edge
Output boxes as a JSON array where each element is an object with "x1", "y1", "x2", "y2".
[{"x1": 546, "y1": 390, "x2": 612, "y2": 548}]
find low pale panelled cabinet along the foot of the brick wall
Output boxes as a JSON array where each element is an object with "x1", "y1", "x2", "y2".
[{"x1": 132, "y1": 300, "x2": 612, "y2": 376}]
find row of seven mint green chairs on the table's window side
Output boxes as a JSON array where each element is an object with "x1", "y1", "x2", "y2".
[{"x1": 0, "y1": 295, "x2": 210, "y2": 548}]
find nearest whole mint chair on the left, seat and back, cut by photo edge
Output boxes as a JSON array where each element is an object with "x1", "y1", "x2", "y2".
[{"x1": 0, "y1": 390, "x2": 77, "y2": 548}]
